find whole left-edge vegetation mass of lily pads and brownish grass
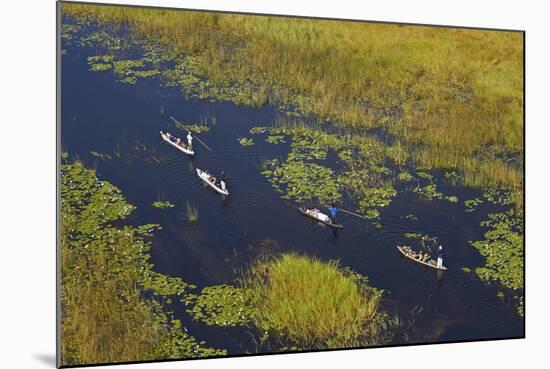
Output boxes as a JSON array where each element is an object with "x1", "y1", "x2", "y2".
[{"x1": 61, "y1": 161, "x2": 226, "y2": 365}]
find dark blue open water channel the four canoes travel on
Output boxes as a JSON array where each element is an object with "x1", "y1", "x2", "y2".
[{"x1": 62, "y1": 21, "x2": 523, "y2": 354}]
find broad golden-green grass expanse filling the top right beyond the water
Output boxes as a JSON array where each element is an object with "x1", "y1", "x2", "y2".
[{"x1": 62, "y1": 4, "x2": 523, "y2": 203}]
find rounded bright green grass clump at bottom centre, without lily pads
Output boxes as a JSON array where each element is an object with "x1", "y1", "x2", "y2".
[{"x1": 242, "y1": 254, "x2": 385, "y2": 349}]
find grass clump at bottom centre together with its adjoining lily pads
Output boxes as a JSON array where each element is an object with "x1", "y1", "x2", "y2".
[{"x1": 188, "y1": 254, "x2": 393, "y2": 350}]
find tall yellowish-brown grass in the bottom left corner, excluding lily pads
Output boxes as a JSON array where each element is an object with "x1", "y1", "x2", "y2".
[{"x1": 61, "y1": 242, "x2": 170, "y2": 365}]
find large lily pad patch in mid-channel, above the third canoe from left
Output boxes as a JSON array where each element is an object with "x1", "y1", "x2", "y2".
[{"x1": 250, "y1": 121, "x2": 397, "y2": 220}]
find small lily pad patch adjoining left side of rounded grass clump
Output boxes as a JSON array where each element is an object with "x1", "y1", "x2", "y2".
[{"x1": 183, "y1": 284, "x2": 253, "y2": 327}]
